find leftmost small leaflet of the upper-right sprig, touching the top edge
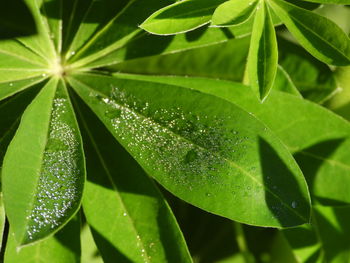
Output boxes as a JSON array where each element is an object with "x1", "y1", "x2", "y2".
[{"x1": 140, "y1": 0, "x2": 224, "y2": 35}]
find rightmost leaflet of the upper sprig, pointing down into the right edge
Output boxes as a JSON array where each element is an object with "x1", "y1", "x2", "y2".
[{"x1": 268, "y1": 0, "x2": 350, "y2": 66}]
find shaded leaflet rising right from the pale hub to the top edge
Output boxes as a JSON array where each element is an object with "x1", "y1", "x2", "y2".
[{"x1": 66, "y1": 0, "x2": 174, "y2": 67}]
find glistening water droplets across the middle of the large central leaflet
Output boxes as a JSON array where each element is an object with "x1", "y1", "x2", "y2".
[{"x1": 95, "y1": 87, "x2": 253, "y2": 196}]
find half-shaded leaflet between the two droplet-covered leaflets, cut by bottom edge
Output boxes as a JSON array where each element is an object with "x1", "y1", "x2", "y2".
[{"x1": 77, "y1": 95, "x2": 192, "y2": 263}]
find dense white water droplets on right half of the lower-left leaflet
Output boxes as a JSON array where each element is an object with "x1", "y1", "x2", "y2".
[{"x1": 27, "y1": 98, "x2": 80, "y2": 239}]
